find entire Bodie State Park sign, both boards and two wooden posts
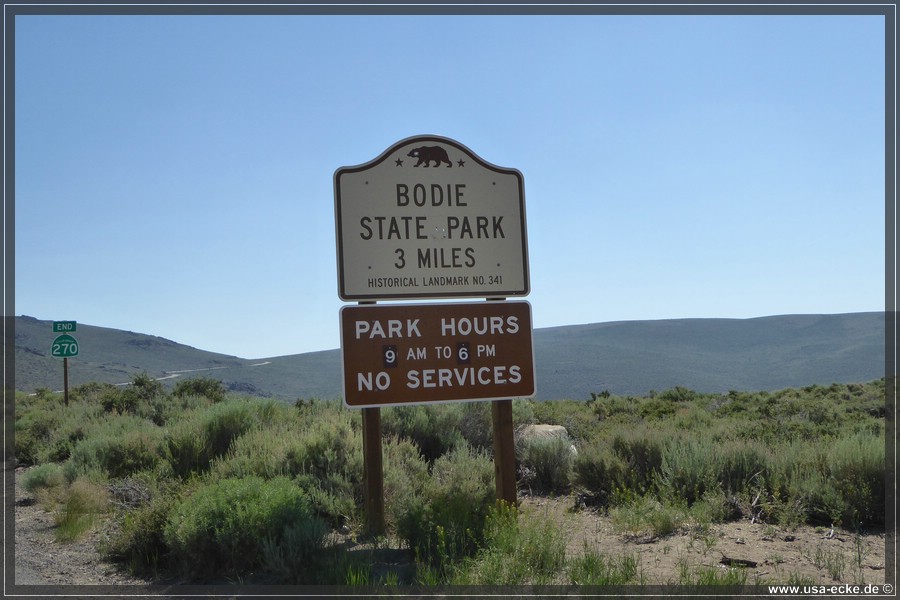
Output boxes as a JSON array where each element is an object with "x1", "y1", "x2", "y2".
[{"x1": 334, "y1": 135, "x2": 535, "y2": 532}]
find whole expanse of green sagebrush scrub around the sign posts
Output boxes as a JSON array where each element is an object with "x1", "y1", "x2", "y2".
[{"x1": 8, "y1": 375, "x2": 885, "y2": 583}]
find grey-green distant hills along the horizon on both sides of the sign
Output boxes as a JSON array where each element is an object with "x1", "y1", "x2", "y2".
[{"x1": 15, "y1": 312, "x2": 885, "y2": 400}]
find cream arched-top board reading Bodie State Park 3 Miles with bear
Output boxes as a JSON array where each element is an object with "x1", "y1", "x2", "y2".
[{"x1": 334, "y1": 136, "x2": 530, "y2": 300}]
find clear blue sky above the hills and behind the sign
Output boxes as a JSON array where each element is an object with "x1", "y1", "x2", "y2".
[{"x1": 15, "y1": 9, "x2": 885, "y2": 358}]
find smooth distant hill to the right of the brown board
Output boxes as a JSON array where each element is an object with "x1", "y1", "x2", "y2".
[{"x1": 534, "y1": 313, "x2": 885, "y2": 399}]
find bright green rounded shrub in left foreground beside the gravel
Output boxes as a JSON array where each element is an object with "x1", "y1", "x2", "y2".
[{"x1": 164, "y1": 477, "x2": 324, "y2": 575}]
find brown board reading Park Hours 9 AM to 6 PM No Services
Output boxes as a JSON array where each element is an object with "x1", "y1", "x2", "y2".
[{"x1": 341, "y1": 301, "x2": 535, "y2": 408}]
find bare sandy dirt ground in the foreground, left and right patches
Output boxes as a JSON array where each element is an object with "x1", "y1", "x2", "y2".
[{"x1": 15, "y1": 469, "x2": 885, "y2": 585}]
